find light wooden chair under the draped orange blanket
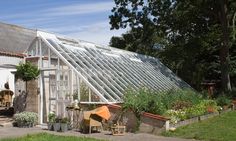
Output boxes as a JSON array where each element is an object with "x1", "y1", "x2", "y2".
[{"x1": 84, "y1": 111, "x2": 103, "y2": 134}]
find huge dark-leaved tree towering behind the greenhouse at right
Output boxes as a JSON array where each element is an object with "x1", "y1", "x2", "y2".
[{"x1": 110, "y1": 0, "x2": 236, "y2": 90}]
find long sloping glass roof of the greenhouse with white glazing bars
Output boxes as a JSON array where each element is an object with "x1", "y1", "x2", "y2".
[{"x1": 37, "y1": 31, "x2": 190, "y2": 103}]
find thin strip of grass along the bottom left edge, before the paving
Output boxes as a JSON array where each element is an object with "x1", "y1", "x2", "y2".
[{"x1": 1, "y1": 133, "x2": 103, "y2": 141}]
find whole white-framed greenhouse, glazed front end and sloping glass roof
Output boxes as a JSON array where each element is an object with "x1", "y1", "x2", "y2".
[{"x1": 26, "y1": 31, "x2": 190, "y2": 122}]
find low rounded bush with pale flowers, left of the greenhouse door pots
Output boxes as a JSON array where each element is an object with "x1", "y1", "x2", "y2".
[{"x1": 14, "y1": 112, "x2": 38, "y2": 128}]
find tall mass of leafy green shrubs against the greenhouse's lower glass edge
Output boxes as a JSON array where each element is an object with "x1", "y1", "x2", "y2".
[{"x1": 123, "y1": 88, "x2": 202, "y2": 116}]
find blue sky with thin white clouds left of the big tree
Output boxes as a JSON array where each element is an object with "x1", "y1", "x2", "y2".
[{"x1": 0, "y1": 0, "x2": 127, "y2": 45}]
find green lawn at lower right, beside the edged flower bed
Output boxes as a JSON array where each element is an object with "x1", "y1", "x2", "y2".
[{"x1": 162, "y1": 111, "x2": 236, "y2": 141}]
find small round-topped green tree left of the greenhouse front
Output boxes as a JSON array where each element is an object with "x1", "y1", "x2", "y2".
[{"x1": 15, "y1": 62, "x2": 40, "y2": 91}]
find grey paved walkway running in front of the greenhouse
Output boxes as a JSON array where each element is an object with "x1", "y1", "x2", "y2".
[{"x1": 0, "y1": 127, "x2": 196, "y2": 141}]
